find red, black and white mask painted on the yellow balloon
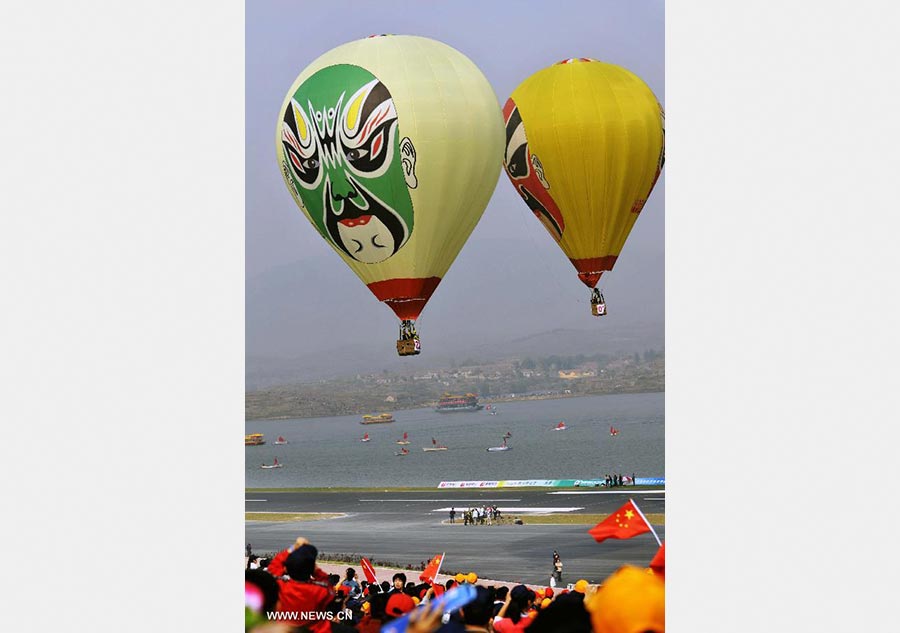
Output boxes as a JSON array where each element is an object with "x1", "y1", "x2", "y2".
[{"x1": 503, "y1": 99, "x2": 566, "y2": 242}]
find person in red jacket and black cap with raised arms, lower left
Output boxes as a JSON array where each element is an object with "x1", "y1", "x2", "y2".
[{"x1": 268, "y1": 537, "x2": 336, "y2": 633}]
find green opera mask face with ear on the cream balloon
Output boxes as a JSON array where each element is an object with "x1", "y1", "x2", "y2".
[{"x1": 281, "y1": 64, "x2": 417, "y2": 264}]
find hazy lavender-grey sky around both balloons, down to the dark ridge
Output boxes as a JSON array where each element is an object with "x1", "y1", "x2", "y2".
[{"x1": 245, "y1": 0, "x2": 665, "y2": 372}]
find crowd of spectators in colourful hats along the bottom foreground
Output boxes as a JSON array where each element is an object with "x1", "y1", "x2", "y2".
[{"x1": 245, "y1": 537, "x2": 665, "y2": 633}]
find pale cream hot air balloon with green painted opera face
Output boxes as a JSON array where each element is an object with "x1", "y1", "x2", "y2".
[{"x1": 276, "y1": 35, "x2": 503, "y2": 356}]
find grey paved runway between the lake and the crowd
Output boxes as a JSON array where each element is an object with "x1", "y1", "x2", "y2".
[{"x1": 245, "y1": 488, "x2": 665, "y2": 583}]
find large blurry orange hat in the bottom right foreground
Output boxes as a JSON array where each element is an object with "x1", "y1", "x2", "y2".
[{"x1": 585, "y1": 565, "x2": 666, "y2": 633}]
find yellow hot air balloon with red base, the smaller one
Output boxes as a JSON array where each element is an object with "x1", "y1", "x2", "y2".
[{"x1": 503, "y1": 58, "x2": 665, "y2": 316}]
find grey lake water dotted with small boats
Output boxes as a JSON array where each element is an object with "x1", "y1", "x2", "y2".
[{"x1": 245, "y1": 393, "x2": 665, "y2": 488}]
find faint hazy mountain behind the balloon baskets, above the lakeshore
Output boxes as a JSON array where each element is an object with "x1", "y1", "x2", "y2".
[{"x1": 246, "y1": 235, "x2": 664, "y2": 390}]
